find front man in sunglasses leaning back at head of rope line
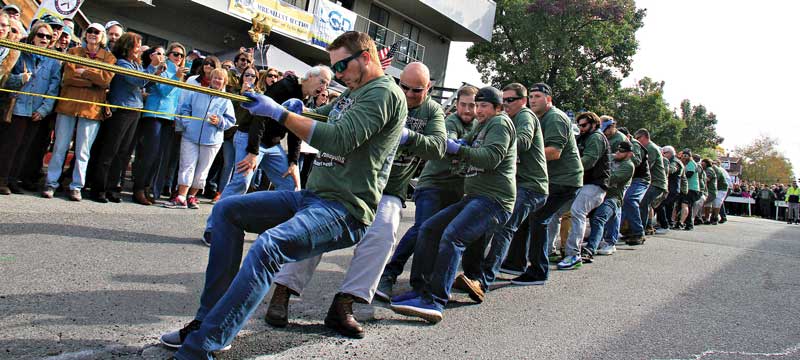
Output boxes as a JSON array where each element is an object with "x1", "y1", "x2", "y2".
[{"x1": 161, "y1": 31, "x2": 408, "y2": 354}]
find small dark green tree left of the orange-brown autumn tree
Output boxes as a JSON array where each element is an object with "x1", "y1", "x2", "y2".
[{"x1": 680, "y1": 100, "x2": 725, "y2": 152}]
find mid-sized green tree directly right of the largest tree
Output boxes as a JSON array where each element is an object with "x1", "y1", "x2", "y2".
[{"x1": 612, "y1": 77, "x2": 686, "y2": 147}]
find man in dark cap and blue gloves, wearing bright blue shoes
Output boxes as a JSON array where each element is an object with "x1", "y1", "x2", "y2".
[{"x1": 391, "y1": 86, "x2": 517, "y2": 323}]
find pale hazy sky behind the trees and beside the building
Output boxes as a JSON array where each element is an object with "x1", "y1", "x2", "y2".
[{"x1": 445, "y1": 0, "x2": 800, "y2": 176}]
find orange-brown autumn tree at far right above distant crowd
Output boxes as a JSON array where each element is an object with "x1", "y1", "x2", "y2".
[{"x1": 734, "y1": 135, "x2": 794, "y2": 184}]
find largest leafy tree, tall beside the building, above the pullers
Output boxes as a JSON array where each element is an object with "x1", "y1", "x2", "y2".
[{"x1": 467, "y1": 0, "x2": 645, "y2": 113}]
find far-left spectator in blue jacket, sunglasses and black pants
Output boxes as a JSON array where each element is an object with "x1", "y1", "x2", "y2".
[{"x1": 0, "y1": 21, "x2": 61, "y2": 195}]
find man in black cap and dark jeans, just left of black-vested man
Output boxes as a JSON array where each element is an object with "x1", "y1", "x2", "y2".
[{"x1": 504, "y1": 83, "x2": 583, "y2": 286}]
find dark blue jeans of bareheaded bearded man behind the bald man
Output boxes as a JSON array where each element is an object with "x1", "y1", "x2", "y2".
[{"x1": 381, "y1": 188, "x2": 464, "y2": 282}]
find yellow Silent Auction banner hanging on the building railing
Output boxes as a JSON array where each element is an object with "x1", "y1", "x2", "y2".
[{"x1": 228, "y1": 0, "x2": 314, "y2": 41}]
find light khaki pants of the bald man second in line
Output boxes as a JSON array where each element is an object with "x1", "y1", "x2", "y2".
[{"x1": 275, "y1": 195, "x2": 403, "y2": 303}]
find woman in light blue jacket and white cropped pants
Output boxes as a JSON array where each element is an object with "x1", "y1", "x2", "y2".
[{"x1": 164, "y1": 69, "x2": 236, "y2": 209}]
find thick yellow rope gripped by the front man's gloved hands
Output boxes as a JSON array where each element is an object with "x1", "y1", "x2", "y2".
[{"x1": 0, "y1": 39, "x2": 328, "y2": 121}]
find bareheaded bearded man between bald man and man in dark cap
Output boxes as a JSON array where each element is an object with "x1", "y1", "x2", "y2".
[{"x1": 375, "y1": 85, "x2": 478, "y2": 302}]
